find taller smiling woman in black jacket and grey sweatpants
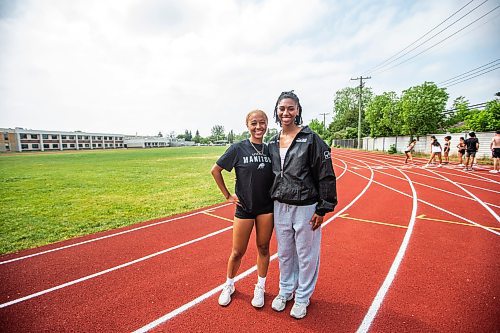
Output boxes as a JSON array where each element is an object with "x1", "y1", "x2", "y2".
[{"x1": 269, "y1": 91, "x2": 337, "y2": 319}]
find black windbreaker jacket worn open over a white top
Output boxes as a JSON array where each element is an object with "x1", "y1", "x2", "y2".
[{"x1": 269, "y1": 126, "x2": 337, "y2": 216}]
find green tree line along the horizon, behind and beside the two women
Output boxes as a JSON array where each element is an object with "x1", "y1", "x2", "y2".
[{"x1": 163, "y1": 82, "x2": 500, "y2": 144}]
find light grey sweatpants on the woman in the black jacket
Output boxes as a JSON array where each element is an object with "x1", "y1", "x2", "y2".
[{"x1": 274, "y1": 201, "x2": 321, "y2": 303}]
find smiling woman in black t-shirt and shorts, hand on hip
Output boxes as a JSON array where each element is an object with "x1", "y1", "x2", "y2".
[{"x1": 211, "y1": 110, "x2": 274, "y2": 308}]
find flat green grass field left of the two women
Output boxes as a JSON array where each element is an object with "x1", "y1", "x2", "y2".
[{"x1": 0, "y1": 147, "x2": 230, "y2": 254}]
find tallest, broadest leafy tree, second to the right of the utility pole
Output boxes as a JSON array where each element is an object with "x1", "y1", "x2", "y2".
[{"x1": 401, "y1": 82, "x2": 448, "y2": 137}]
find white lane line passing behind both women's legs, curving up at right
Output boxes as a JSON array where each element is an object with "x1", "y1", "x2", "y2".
[{"x1": 134, "y1": 158, "x2": 373, "y2": 333}]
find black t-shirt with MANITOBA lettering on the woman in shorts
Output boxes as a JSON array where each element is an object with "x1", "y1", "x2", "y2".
[{"x1": 217, "y1": 140, "x2": 274, "y2": 212}]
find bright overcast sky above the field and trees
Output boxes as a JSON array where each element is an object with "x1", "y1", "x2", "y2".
[{"x1": 0, "y1": 0, "x2": 500, "y2": 136}]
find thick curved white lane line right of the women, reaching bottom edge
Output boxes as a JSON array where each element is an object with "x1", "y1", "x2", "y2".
[{"x1": 356, "y1": 157, "x2": 418, "y2": 333}]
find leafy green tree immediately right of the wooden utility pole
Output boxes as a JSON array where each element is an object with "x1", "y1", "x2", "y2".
[{"x1": 365, "y1": 91, "x2": 401, "y2": 137}]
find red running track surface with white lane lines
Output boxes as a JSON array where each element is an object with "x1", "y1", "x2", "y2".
[{"x1": 0, "y1": 149, "x2": 500, "y2": 332}]
